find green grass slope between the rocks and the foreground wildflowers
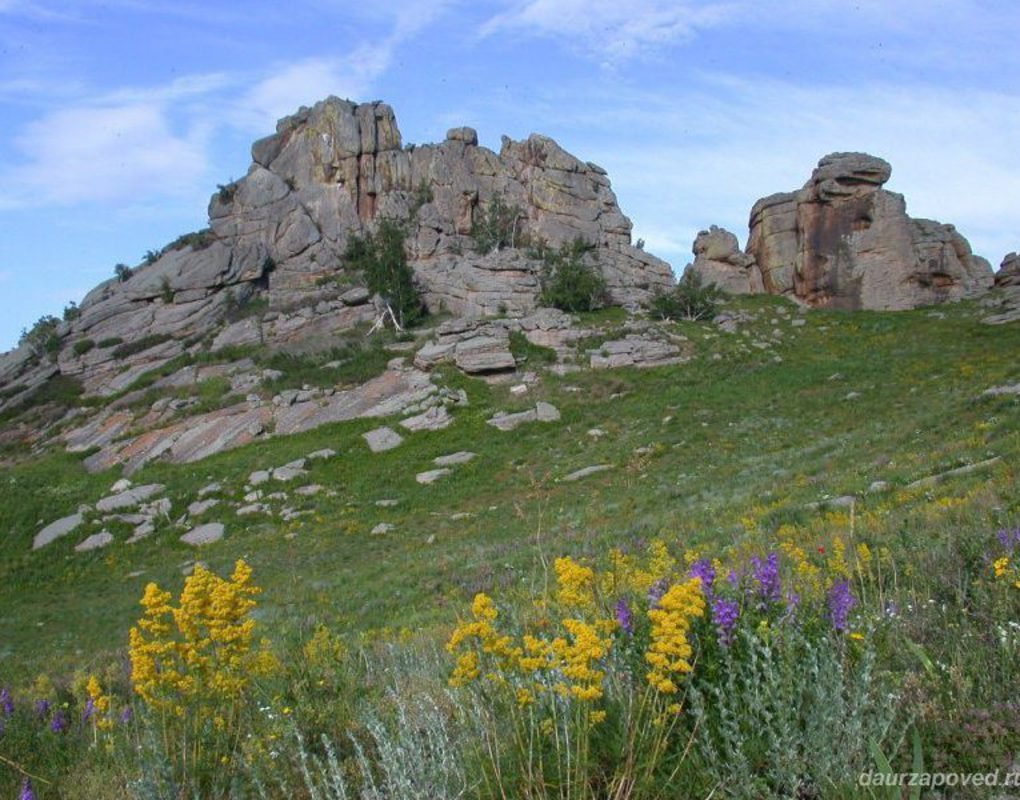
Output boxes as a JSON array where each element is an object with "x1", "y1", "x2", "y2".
[{"x1": 0, "y1": 298, "x2": 1020, "y2": 676}]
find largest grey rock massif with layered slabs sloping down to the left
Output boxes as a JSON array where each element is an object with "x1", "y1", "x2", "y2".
[{"x1": 0, "y1": 98, "x2": 672, "y2": 410}]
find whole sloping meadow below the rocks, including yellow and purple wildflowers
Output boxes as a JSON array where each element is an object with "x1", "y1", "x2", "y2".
[{"x1": 0, "y1": 297, "x2": 1020, "y2": 800}]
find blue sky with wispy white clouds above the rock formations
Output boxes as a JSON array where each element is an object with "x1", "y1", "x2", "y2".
[{"x1": 0, "y1": 0, "x2": 1020, "y2": 350}]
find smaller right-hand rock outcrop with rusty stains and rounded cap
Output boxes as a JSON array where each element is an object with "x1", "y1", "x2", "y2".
[{"x1": 748, "y1": 153, "x2": 992, "y2": 309}]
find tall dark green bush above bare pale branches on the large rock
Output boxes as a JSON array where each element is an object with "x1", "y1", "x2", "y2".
[{"x1": 344, "y1": 219, "x2": 423, "y2": 326}]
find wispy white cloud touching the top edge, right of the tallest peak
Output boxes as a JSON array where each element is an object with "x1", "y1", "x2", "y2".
[{"x1": 481, "y1": 0, "x2": 734, "y2": 62}]
